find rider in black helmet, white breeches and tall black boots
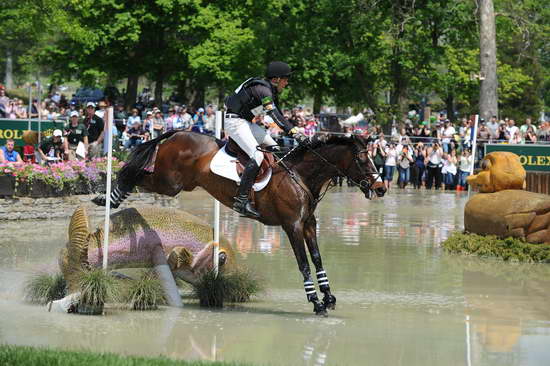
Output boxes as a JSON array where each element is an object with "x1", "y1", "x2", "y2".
[{"x1": 225, "y1": 61, "x2": 307, "y2": 217}]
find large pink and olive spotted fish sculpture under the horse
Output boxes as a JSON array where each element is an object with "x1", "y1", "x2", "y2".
[{"x1": 54, "y1": 206, "x2": 235, "y2": 309}]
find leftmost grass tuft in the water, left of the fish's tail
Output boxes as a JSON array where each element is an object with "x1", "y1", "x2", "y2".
[{"x1": 25, "y1": 273, "x2": 67, "y2": 305}]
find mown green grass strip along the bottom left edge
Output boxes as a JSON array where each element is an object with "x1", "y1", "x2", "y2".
[{"x1": 0, "y1": 345, "x2": 252, "y2": 366}]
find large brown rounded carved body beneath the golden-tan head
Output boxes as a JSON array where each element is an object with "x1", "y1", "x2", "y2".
[{"x1": 464, "y1": 190, "x2": 550, "y2": 243}]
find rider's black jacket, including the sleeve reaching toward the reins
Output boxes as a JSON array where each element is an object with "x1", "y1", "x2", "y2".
[{"x1": 225, "y1": 78, "x2": 294, "y2": 134}]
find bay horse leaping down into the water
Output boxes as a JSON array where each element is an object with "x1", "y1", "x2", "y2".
[{"x1": 94, "y1": 130, "x2": 386, "y2": 316}]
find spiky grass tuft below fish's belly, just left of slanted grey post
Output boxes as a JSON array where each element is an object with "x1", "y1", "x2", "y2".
[{"x1": 124, "y1": 271, "x2": 166, "y2": 310}]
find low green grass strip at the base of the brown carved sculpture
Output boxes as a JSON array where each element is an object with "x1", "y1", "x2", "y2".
[{"x1": 441, "y1": 232, "x2": 550, "y2": 263}]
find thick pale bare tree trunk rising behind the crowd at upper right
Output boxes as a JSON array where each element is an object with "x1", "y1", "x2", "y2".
[{"x1": 479, "y1": 0, "x2": 498, "y2": 121}]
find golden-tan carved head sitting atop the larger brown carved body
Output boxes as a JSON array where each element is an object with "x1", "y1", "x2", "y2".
[{"x1": 467, "y1": 151, "x2": 526, "y2": 193}]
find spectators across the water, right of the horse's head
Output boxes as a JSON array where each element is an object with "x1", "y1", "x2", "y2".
[{"x1": 346, "y1": 114, "x2": 550, "y2": 191}]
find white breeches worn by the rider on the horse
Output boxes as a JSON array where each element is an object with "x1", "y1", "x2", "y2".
[{"x1": 225, "y1": 118, "x2": 277, "y2": 165}]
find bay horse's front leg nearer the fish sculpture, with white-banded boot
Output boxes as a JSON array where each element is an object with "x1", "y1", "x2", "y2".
[{"x1": 284, "y1": 227, "x2": 327, "y2": 316}]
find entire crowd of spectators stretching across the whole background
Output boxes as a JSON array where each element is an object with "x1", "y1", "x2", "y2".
[{"x1": 0, "y1": 87, "x2": 550, "y2": 190}]
